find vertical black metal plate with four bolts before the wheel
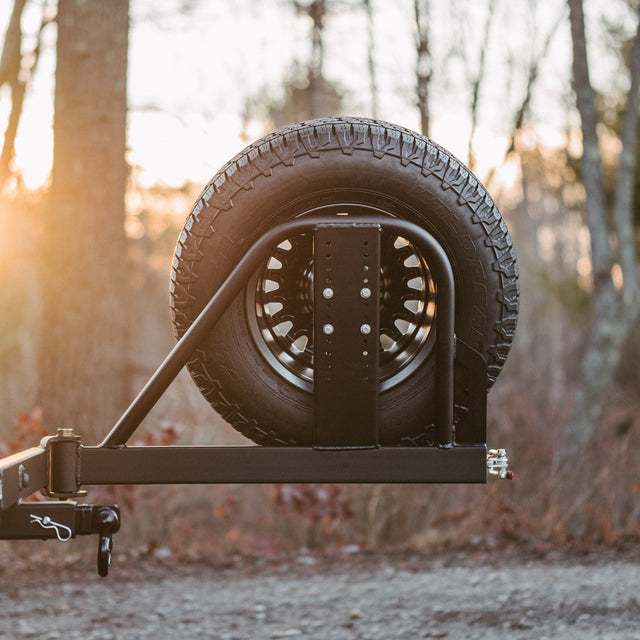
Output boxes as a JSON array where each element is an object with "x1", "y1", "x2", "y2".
[{"x1": 313, "y1": 224, "x2": 382, "y2": 449}]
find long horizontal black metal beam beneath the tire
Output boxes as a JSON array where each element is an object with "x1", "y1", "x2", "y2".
[{"x1": 80, "y1": 445, "x2": 487, "y2": 486}]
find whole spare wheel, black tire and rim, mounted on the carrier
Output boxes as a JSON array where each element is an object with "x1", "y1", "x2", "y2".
[{"x1": 171, "y1": 118, "x2": 519, "y2": 446}]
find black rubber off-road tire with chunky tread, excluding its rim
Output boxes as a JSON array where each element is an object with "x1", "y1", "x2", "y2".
[{"x1": 171, "y1": 118, "x2": 519, "y2": 445}]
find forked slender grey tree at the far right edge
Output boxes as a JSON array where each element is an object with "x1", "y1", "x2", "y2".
[{"x1": 560, "y1": 0, "x2": 640, "y2": 461}]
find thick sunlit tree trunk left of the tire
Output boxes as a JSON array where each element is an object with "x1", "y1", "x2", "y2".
[{"x1": 39, "y1": 0, "x2": 129, "y2": 438}]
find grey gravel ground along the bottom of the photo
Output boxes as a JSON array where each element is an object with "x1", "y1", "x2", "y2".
[{"x1": 0, "y1": 553, "x2": 640, "y2": 640}]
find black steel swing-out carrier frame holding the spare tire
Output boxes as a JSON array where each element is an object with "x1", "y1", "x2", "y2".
[{"x1": 0, "y1": 215, "x2": 487, "y2": 575}]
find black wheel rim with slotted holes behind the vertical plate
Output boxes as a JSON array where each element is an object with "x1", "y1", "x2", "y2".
[{"x1": 246, "y1": 212, "x2": 436, "y2": 390}]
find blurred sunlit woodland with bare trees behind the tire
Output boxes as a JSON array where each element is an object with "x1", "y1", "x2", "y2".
[{"x1": 0, "y1": 0, "x2": 640, "y2": 557}]
